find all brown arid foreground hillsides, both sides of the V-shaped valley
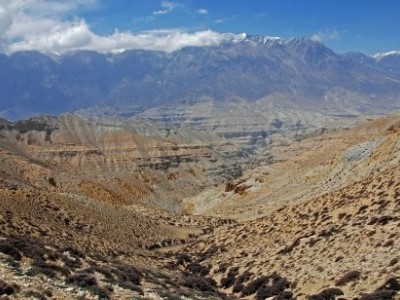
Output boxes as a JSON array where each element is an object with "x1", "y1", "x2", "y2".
[{"x1": 0, "y1": 114, "x2": 400, "y2": 300}]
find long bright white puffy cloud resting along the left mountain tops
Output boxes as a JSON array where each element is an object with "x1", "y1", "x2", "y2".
[{"x1": 8, "y1": 20, "x2": 228, "y2": 54}]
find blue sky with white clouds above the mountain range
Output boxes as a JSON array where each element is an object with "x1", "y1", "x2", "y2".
[{"x1": 0, "y1": 0, "x2": 400, "y2": 55}]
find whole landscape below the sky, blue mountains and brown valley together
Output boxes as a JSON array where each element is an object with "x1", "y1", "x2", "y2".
[{"x1": 0, "y1": 34, "x2": 400, "y2": 300}]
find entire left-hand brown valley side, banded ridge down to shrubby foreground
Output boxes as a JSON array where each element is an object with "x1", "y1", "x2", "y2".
[{"x1": 0, "y1": 114, "x2": 238, "y2": 299}]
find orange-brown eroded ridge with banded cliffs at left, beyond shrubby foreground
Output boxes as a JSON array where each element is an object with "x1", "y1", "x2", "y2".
[{"x1": 0, "y1": 114, "x2": 242, "y2": 211}]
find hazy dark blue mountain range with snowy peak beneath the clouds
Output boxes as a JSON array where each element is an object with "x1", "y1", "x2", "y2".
[{"x1": 0, "y1": 36, "x2": 400, "y2": 118}]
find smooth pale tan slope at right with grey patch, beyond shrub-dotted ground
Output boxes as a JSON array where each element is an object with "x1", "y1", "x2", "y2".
[{"x1": 184, "y1": 117, "x2": 400, "y2": 220}]
